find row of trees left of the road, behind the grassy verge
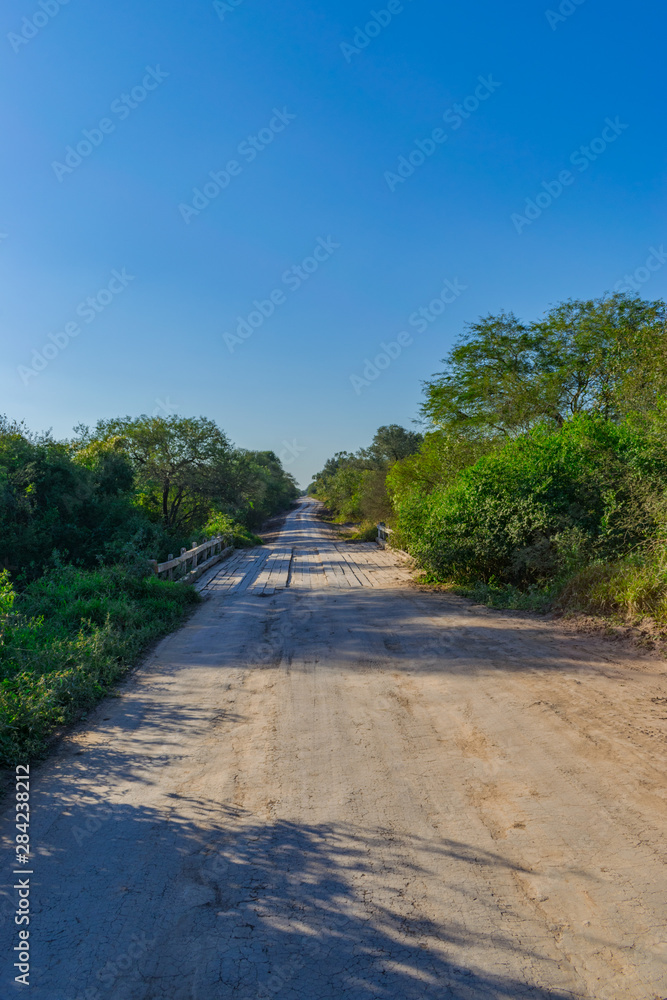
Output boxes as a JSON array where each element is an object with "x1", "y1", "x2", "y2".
[{"x1": 0, "y1": 417, "x2": 298, "y2": 581}]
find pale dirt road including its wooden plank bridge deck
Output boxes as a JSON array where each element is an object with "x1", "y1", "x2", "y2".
[{"x1": 0, "y1": 503, "x2": 667, "y2": 1000}]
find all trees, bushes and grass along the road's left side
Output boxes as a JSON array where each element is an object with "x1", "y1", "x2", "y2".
[{"x1": 0, "y1": 416, "x2": 298, "y2": 765}]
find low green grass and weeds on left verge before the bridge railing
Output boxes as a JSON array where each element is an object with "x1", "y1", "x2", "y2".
[{"x1": 0, "y1": 567, "x2": 199, "y2": 766}]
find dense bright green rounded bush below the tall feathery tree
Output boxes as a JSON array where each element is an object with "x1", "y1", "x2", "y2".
[{"x1": 395, "y1": 415, "x2": 667, "y2": 589}]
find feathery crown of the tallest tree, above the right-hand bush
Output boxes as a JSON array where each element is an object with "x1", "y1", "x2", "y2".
[{"x1": 423, "y1": 294, "x2": 667, "y2": 438}]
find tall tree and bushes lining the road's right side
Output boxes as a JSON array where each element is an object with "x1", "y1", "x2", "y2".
[{"x1": 313, "y1": 295, "x2": 667, "y2": 625}]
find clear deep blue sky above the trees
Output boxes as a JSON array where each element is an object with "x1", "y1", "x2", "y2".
[{"x1": 0, "y1": 0, "x2": 667, "y2": 485}]
